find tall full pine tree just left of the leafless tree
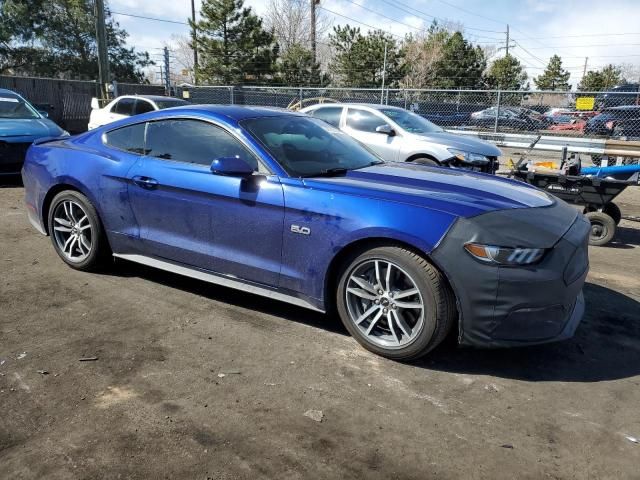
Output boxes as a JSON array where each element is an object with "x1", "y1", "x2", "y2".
[{"x1": 195, "y1": 0, "x2": 278, "y2": 84}]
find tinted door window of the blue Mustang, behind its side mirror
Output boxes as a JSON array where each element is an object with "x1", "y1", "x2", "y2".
[{"x1": 145, "y1": 119, "x2": 259, "y2": 170}]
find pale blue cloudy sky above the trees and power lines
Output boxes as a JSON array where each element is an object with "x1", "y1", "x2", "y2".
[{"x1": 107, "y1": 0, "x2": 640, "y2": 86}]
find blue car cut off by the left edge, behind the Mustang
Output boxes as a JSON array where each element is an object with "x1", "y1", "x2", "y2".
[{"x1": 0, "y1": 88, "x2": 69, "y2": 175}]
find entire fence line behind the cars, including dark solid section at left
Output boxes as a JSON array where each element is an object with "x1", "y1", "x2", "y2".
[{"x1": 5, "y1": 76, "x2": 640, "y2": 140}]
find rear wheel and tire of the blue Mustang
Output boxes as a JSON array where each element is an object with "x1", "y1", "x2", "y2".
[{"x1": 48, "y1": 190, "x2": 111, "y2": 271}]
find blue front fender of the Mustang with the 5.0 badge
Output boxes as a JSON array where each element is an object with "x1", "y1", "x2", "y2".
[{"x1": 280, "y1": 182, "x2": 457, "y2": 301}]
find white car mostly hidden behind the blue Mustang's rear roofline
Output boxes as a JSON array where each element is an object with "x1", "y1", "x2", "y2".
[{"x1": 89, "y1": 95, "x2": 189, "y2": 130}]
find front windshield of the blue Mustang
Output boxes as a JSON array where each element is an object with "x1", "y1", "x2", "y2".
[{"x1": 241, "y1": 116, "x2": 383, "y2": 177}]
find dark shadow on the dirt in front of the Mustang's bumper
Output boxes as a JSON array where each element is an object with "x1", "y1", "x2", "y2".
[{"x1": 417, "y1": 283, "x2": 640, "y2": 382}]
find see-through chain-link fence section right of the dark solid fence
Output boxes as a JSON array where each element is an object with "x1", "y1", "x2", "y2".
[{"x1": 176, "y1": 86, "x2": 640, "y2": 140}]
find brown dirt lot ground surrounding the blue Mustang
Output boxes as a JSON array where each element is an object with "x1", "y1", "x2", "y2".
[{"x1": 0, "y1": 182, "x2": 640, "y2": 479}]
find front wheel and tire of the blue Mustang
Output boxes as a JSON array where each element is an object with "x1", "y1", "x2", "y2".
[{"x1": 336, "y1": 247, "x2": 457, "y2": 361}]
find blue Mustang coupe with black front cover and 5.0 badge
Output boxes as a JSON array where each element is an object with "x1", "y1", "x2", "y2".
[{"x1": 22, "y1": 106, "x2": 590, "y2": 360}]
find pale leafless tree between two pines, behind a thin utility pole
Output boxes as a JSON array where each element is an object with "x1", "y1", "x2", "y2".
[{"x1": 264, "y1": 0, "x2": 331, "y2": 52}]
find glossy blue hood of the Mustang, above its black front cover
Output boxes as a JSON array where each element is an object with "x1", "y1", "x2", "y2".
[{"x1": 304, "y1": 162, "x2": 556, "y2": 217}]
